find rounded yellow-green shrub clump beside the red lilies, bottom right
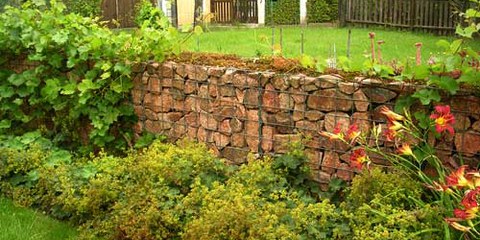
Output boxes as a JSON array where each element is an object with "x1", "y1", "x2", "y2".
[{"x1": 341, "y1": 168, "x2": 443, "y2": 240}]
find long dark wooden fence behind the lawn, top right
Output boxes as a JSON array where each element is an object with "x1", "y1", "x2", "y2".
[{"x1": 339, "y1": 0, "x2": 460, "y2": 34}]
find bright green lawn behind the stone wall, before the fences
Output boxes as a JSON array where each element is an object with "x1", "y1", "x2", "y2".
[{"x1": 181, "y1": 26, "x2": 480, "y2": 67}]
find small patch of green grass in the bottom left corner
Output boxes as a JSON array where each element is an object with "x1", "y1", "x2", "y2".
[{"x1": 0, "y1": 197, "x2": 77, "y2": 240}]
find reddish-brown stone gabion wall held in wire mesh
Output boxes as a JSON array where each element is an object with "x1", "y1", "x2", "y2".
[{"x1": 132, "y1": 62, "x2": 480, "y2": 182}]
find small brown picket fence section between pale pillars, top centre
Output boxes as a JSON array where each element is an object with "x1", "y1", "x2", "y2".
[{"x1": 211, "y1": 0, "x2": 258, "y2": 23}]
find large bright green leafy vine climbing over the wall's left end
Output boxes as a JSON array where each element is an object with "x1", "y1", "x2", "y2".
[{"x1": 0, "y1": 0, "x2": 176, "y2": 153}]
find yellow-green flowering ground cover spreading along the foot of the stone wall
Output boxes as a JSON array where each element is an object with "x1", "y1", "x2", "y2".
[{"x1": 0, "y1": 134, "x2": 442, "y2": 239}]
